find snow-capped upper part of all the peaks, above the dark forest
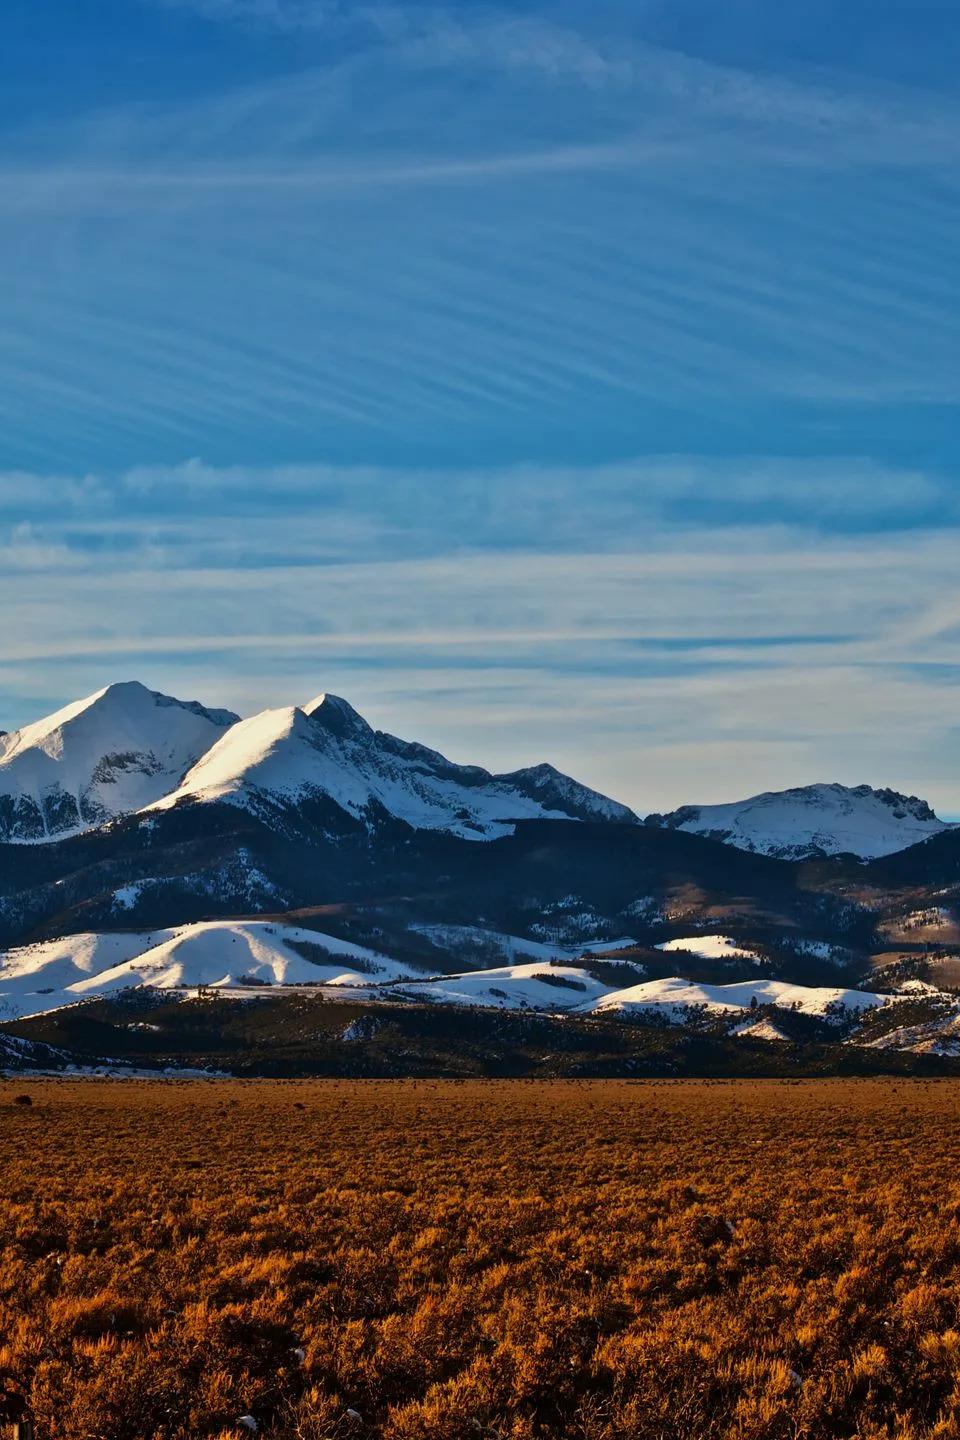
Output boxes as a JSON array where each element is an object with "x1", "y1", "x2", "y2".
[{"x1": 0, "y1": 681, "x2": 950, "y2": 860}]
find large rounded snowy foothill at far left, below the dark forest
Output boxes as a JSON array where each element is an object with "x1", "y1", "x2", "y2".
[{"x1": 0, "y1": 920, "x2": 416, "y2": 1018}]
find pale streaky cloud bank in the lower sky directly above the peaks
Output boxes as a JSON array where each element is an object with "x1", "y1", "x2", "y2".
[{"x1": 0, "y1": 456, "x2": 960, "y2": 808}]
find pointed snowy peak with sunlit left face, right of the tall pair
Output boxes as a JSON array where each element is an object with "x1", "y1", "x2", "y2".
[{"x1": 146, "y1": 696, "x2": 636, "y2": 840}]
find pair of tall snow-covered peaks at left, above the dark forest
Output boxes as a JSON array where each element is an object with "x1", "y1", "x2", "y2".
[{"x1": 0, "y1": 681, "x2": 638, "y2": 842}]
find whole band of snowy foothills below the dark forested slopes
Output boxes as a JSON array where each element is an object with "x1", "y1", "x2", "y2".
[{"x1": 0, "y1": 920, "x2": 921, "y2": 1063}]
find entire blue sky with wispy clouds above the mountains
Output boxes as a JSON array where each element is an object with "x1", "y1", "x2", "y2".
[{"x1": 0, "y1": 0, "x2": 960, "y2": 814}]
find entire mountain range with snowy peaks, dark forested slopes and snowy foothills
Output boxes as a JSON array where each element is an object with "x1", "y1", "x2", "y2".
[{"x1": 0, "y1": 683, "x2": 960, "y2": 1077}]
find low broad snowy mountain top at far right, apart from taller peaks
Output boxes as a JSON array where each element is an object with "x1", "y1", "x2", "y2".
[{"x1": 645, "y1": 785, "x2": 951, "y2": 860}]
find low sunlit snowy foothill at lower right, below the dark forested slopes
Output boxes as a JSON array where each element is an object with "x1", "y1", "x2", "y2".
[{"x1": 590, "y1": 975, "x2": 888, "y2": 1024}]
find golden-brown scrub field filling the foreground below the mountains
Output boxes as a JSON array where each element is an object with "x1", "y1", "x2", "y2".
[{"x1": 0, "y1": 1077, "x2": 960, "y2": 1440}]
